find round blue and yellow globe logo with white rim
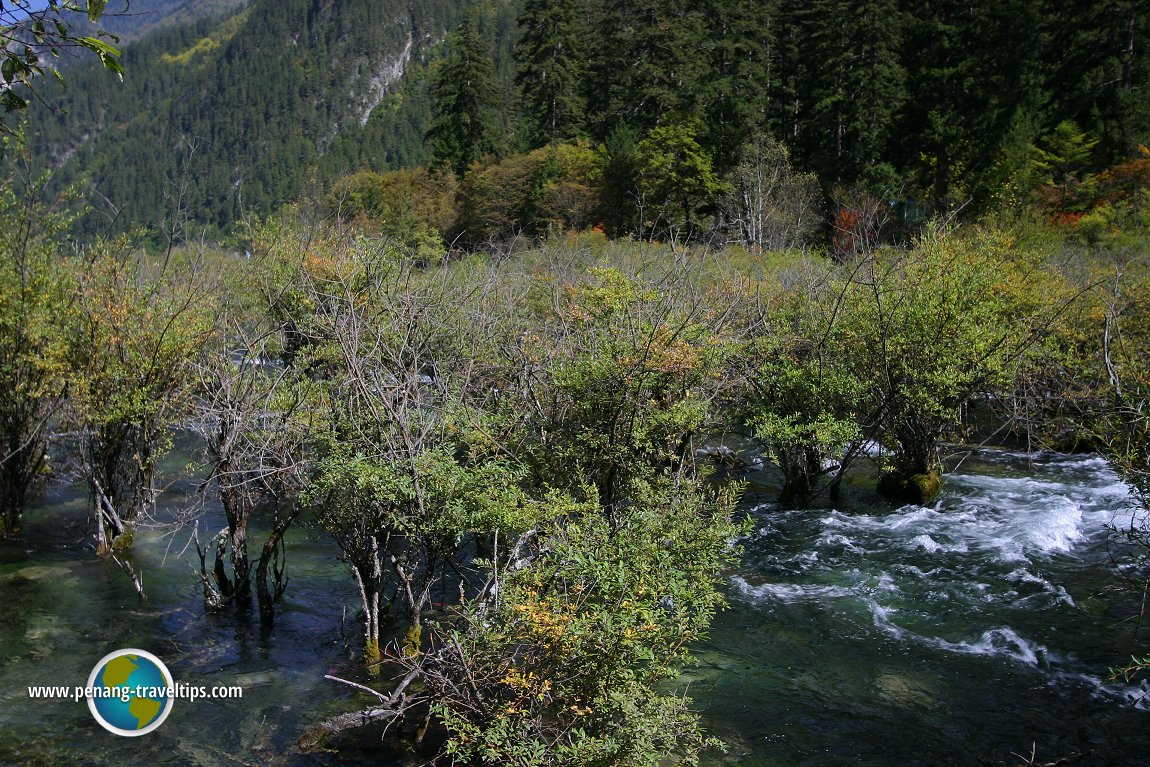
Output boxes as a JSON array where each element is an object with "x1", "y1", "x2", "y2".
[{"x1": 87, "y1": 649, "x2": 175, "y2": 737}]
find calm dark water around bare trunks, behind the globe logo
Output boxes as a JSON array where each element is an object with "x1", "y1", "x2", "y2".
[{"x1": 0, "y1": 473, "x2": 391, "y2": 766}]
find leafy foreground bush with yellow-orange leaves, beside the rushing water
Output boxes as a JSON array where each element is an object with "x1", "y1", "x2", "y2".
[{"x1": 404, "y1": 475, "x2": 738, "y2": 766}]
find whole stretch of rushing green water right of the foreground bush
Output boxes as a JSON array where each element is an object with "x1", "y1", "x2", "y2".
[{"x1": 690, "y1": 452, "x2": 1150, "y2": 767}]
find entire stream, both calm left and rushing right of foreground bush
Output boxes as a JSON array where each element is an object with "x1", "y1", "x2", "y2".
[{"x1": 0, "y1": 451, "x2": 1150, "y2": 767}]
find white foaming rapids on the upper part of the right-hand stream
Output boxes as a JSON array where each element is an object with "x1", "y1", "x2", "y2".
[{"x1": 733, "y1": 454, "x2": 1145, "y2": 675}]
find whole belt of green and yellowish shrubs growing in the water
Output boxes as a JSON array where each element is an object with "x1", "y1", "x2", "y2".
[{"x1": 0, "y1": 145, "x2": 1150, "y2": 764}]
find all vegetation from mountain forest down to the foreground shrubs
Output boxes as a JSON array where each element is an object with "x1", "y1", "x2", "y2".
[{"x1": 0, "y1": 0, "x2": 1150, "y2": 766}]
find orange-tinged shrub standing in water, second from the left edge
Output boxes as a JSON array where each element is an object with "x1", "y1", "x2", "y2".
[{"x1": 66, "y1": 248, "x2": 212, "y2": 553}]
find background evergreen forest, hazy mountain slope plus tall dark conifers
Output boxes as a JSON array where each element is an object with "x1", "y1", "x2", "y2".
[{"x1": 15, "y1": 0, "x2": 1150, "y2": 242}]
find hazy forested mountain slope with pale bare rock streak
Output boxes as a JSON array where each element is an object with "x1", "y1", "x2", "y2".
[{"x1": 29, "y1": 0, "x2": 487, "y2": 233}]
